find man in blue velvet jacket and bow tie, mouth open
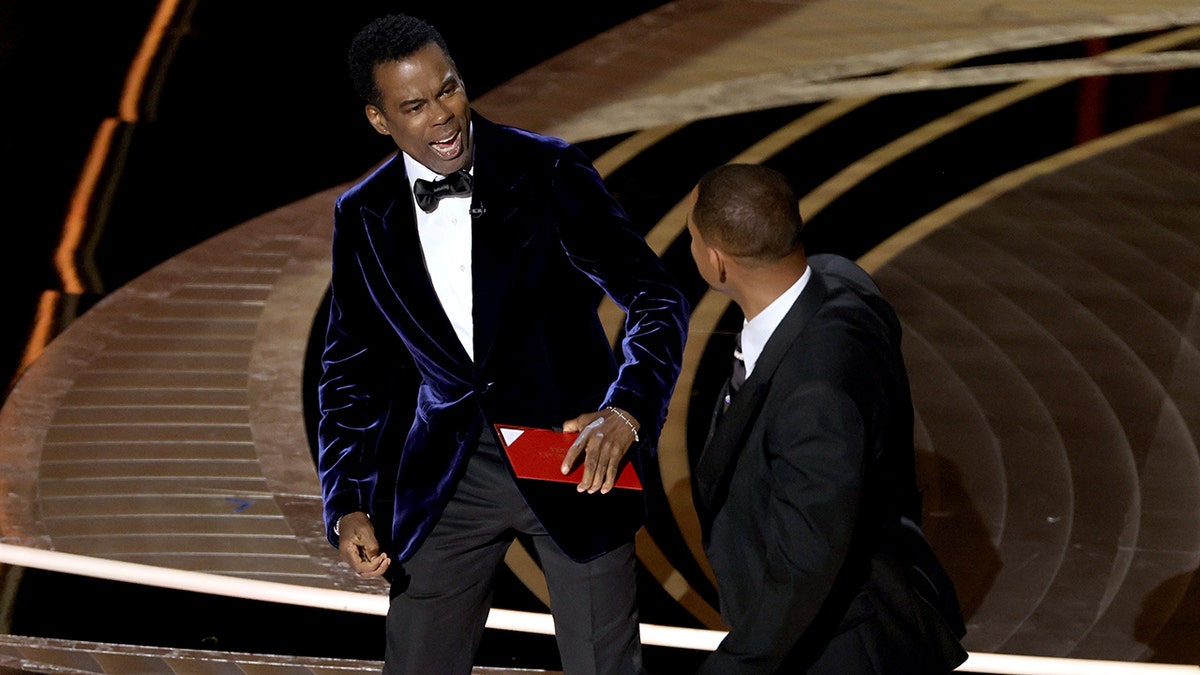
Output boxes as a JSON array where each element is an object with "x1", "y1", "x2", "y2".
[{"x1": 318, "y1": 16, "x2": 689, "y2": 675}]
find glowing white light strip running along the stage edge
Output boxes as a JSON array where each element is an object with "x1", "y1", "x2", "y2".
[{"x1": 0, "y1": 544, "x2": 1200, "y2": 675}]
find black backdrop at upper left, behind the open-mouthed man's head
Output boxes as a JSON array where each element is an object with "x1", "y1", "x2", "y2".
[{"x1": 0, "y1": 0, "x2": 662, "y2": 393}]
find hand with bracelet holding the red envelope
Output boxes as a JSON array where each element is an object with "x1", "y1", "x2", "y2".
[{"x1": 562, "y1": 408, "x2": 640, "y2": 495}]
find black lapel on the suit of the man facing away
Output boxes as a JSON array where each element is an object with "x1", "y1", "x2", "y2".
[{"x1": 692, "y1": 270, "x2": 828, "y2": 514}]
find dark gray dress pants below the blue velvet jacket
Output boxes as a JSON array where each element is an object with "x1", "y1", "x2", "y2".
[{"x1": 384, "y1": 434, "x2": 643, "y2": 675}]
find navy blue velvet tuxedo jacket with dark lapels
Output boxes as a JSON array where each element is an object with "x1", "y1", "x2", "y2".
[{"x1": 318, "y1": 113, "x2": 690, "y2": 561}]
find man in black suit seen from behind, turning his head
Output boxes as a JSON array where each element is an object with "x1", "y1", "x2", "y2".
[{"x1": 688, "y1": 165, "x2": 966, "y2": 675}]
